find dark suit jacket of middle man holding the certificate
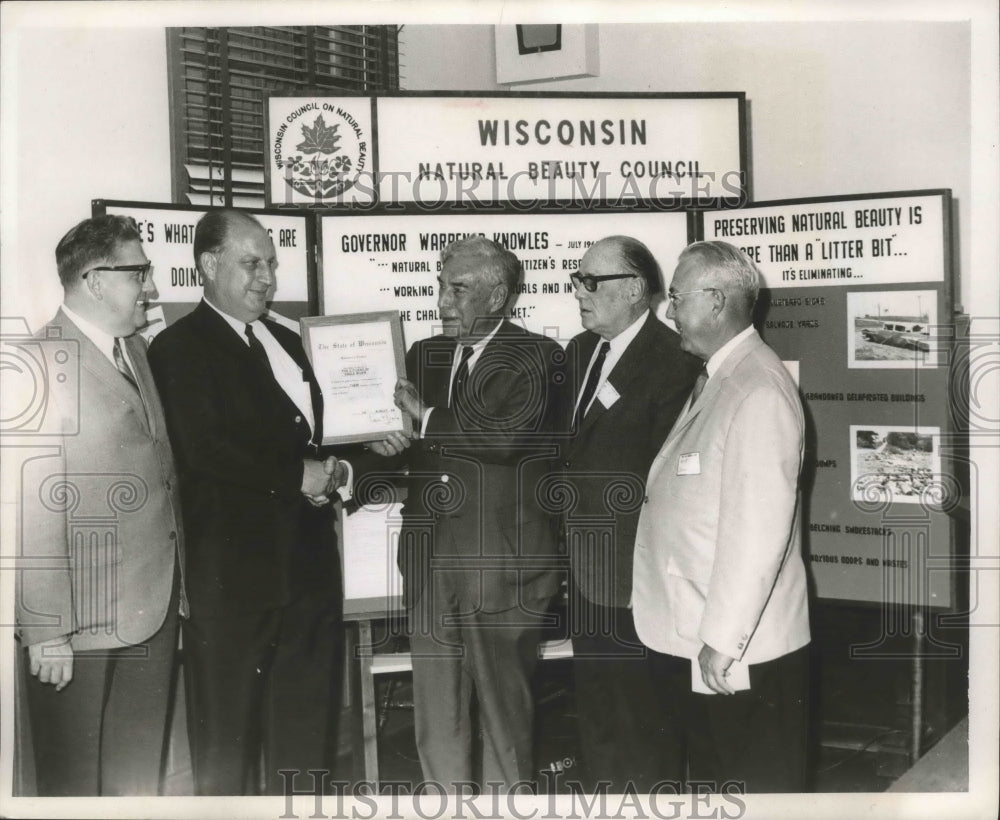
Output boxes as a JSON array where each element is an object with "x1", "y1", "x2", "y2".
[{"x1": 388, "y1": 321, "x2": 565, "y2": 612}]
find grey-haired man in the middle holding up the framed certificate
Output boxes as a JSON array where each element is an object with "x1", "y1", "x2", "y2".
[{"x1": 373, "y1": 236, "x2": 564, "y2": 791}]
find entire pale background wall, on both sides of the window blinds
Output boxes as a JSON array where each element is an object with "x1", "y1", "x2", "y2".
[{"x1": 3, "y1": 21, "x2": 970, "y2": 327}]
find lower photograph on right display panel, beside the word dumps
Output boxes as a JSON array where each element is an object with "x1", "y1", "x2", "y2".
[{"x1": 851, "y1": 425, "x2": 941, "y2": 504}]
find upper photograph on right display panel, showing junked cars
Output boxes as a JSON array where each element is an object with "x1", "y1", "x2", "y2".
[{"x1": 847, "y1": 290, "x2": 938, "y2": 368}]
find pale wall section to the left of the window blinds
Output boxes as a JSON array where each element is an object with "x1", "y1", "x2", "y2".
[{"x1": 2, "y1": 26, "x2": 170, "y2": 329}]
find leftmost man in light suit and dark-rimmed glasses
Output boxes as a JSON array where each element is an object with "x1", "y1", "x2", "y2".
[{"x1": 17, "y1": 216, "x2": 186, "y2": 796}]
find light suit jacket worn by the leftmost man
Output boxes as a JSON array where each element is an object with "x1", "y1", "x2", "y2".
[{"x1": 17, "y1": 310, "x2": 186, "y2": 650}]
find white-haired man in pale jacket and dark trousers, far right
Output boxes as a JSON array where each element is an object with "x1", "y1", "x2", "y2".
[{"x1": 633, "y1": 242, "x2": 809, "y2": 792}]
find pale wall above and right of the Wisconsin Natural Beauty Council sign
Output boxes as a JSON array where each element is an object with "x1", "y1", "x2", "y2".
[{"x1": 401, "y1": 21, "x2": 971, "y2": 310}]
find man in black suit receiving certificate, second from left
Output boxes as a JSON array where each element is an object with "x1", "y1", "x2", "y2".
[{"x1": 149, "y1": 211, "x2": 343, "y2": 795}]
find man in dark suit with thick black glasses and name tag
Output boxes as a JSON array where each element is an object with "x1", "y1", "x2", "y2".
[{"x1": 563, "y1": 236, "x2": 700, "y2": 793}]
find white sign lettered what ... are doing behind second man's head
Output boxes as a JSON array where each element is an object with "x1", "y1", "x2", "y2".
[{"x1": 92, "y1": 199, "x2": 317, "y2": 340}]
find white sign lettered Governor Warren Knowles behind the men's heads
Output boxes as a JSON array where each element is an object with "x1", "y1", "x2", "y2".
[{"x1": 319, "y1": 212, "x2": 688, "y2": 347}]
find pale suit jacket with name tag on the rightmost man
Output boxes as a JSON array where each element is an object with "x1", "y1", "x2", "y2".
[{"x1": 633, "y1": 333, "x2": 809, "y2": 663}]
